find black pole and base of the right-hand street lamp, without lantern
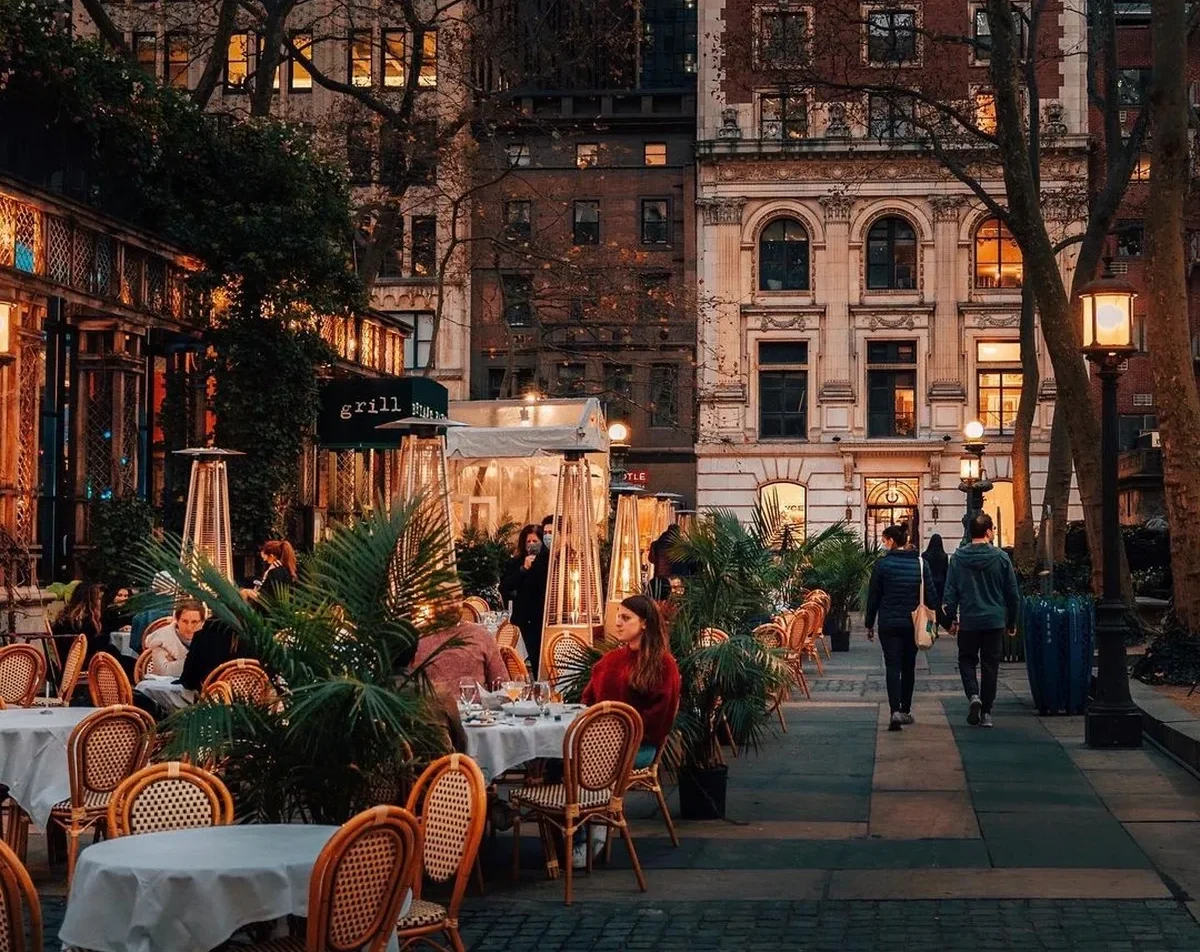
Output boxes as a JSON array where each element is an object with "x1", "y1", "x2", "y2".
[{"x1": 1084, "y1": 353, "x2": 1141, "y2": 748}]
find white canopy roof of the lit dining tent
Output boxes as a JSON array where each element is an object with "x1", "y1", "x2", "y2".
[{"x1": 446, "y1": 397, "x2": 608, "y2": 460}]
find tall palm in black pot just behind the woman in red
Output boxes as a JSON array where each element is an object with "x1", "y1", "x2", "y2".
[{"x1": 671, "y1": 511, "x2": 787, "y2": 819}]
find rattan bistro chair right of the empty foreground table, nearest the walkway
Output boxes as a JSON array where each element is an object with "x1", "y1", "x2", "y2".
[{"x1": 396, "y1": 754, "x2": 487, "y2": 952}]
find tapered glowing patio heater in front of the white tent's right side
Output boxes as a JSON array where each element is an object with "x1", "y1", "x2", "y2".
[{"x1": 542, "y1": 449, "x2": 605, "y2": 672}]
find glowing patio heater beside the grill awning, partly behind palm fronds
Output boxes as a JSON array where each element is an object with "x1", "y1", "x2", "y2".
[{"x1": 376, "y1": 417, "x2": 466, "y2": 625}]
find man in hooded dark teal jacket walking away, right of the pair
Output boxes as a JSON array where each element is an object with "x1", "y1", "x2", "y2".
[{"x1": 944, "y1": 513, "x2": 1021, "y2": 728}]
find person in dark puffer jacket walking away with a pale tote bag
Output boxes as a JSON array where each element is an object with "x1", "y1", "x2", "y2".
[{"x1": 865, "y1": 526, "x2": 937, "y2": 731}]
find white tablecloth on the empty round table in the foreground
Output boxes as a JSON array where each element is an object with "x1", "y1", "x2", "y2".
[{"x1": 59, "y1": 825, "x2": 405, "y2": 952}]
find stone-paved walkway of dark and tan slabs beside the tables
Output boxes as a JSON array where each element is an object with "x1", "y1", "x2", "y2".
[{"x1": 462, "y1": 635, "x2": 1200, "y2": 952}]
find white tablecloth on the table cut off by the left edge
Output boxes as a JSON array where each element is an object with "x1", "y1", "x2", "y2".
[{"x1": 0, "y1": 707, "x2": 95, "y2": 828}]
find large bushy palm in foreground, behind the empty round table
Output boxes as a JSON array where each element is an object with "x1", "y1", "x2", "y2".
[{"x1": 129, "y1": 499, "x2": 456, "y2": 824}]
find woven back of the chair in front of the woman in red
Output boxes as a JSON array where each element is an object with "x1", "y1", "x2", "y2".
[{"x1": 563, "y1": 701, "x2": 642, "y2": 804}]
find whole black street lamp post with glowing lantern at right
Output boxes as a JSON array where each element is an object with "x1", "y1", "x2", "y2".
[{"x1": 1079, "y1": 261, "x2": 1141, "y2": 748}]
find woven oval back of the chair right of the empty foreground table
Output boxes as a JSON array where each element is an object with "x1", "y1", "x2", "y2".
[{"x1": 408, "y1": 754, "x2": 487, "y2": 918}]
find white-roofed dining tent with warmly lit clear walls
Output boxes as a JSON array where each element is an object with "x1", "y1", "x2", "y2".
[{"x1": 446, "y1": 397, "x2": 608, "y2": 535}]
